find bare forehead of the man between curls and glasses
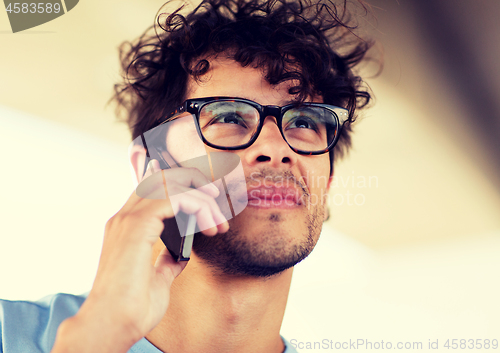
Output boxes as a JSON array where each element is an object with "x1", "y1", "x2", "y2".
[{"x1": 186, "y1": 57, "x2": 312, "y2": 105}]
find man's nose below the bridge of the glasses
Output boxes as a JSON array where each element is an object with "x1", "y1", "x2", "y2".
[{"x1": 244, "y1": 116, "x2": 297, "y2": 168}]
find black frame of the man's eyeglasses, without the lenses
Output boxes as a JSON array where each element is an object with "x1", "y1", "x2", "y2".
[{"x1": 160, "y1": 97, "x2": 349, "y2": 155}]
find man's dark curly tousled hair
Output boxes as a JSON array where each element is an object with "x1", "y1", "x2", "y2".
[{"x1": 112, "y1": 0, "x2": 372, "y2": 167}]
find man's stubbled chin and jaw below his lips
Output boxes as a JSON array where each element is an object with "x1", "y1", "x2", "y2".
[{"x1": 193, "y1": 206, "x2": 323, "y2": 278}]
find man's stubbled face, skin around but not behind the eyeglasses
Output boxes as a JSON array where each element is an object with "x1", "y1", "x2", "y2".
[{"x1": 163, "y1": 59, "x2": 330, "y2": 276}]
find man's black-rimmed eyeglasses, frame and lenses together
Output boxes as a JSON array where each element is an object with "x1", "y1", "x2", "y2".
[{"x1": 165, "y1": 97, "x2": 349, "y2": 155}]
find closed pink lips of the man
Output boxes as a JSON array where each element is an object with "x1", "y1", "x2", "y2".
[{"x1": 248, "y1": 187, "x2": 301, "y2": 208}]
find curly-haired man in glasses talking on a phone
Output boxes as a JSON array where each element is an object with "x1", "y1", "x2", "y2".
[{"x1": 3, "y1": 0, "x2": 370, "y2": 353}]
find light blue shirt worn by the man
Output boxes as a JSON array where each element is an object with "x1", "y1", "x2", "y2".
[{"x1": 0, "y1": 293, "x2": 297, "y2": 353}]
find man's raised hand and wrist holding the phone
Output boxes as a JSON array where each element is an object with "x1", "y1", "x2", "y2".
[{"x1": 53, "y1": 161, "x2": 229, "y2": 352}]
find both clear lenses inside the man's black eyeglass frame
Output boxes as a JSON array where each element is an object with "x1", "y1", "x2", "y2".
[{"x1": 199, "y1": 101, "x2": 337, "y2": 152}]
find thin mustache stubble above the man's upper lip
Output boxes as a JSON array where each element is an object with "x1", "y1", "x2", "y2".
[{"x1": 245, "y1": 168, "x2": 310, "y2": 196}]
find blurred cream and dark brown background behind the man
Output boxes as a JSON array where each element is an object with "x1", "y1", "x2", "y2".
[{"x1": 0, "y1": 0, "x2": 500, "y2": 351}]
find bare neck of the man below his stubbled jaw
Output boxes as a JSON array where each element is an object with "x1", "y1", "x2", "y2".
[{"x1": 146, "y1": 250, "x2": 293, "y2": 353}]
